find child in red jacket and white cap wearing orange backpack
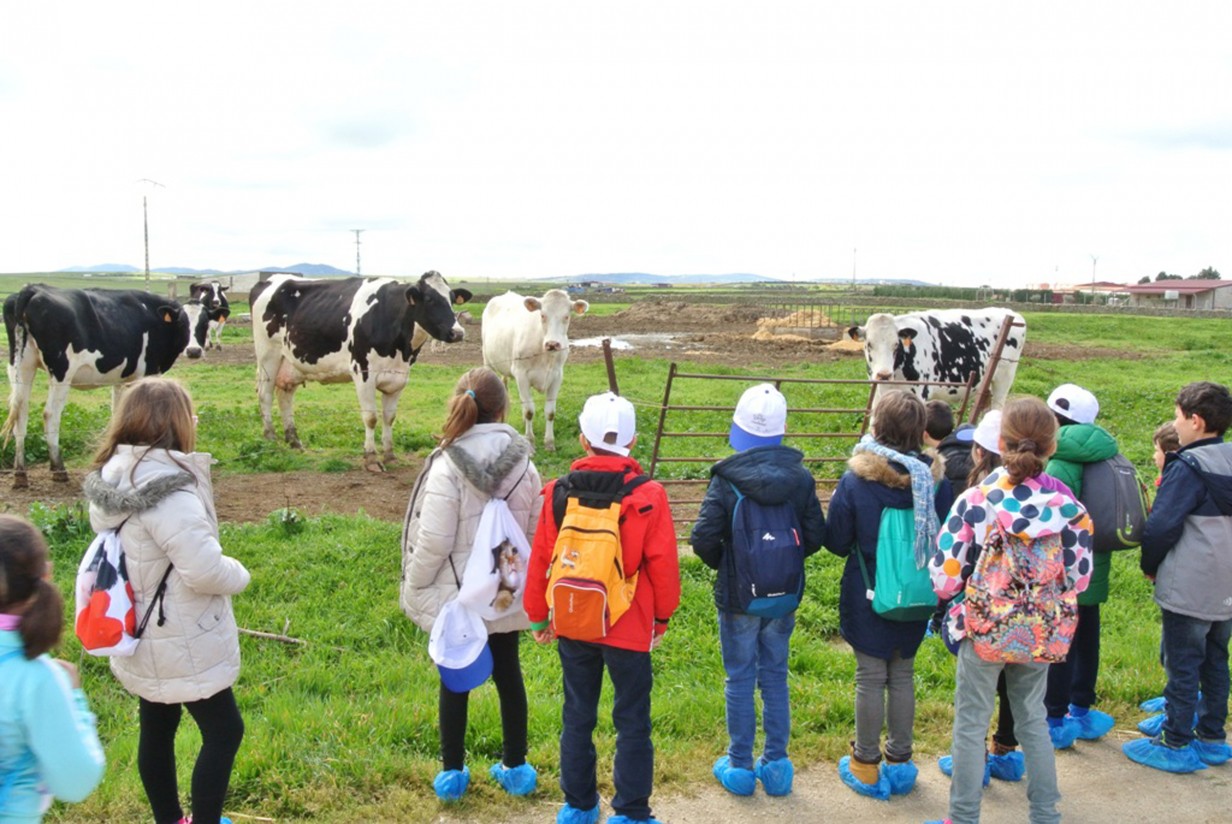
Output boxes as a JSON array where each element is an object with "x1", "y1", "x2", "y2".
[{"x1": 524, "y1": 392, "x2": 680, "y2": 824}]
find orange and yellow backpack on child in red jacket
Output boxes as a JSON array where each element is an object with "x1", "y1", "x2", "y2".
[{"x1": 547, "y1": 472, "x2": 649, "y2": 640}]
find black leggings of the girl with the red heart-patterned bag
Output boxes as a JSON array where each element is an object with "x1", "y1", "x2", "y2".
[{"x1": 137, "y1": 687, "x2": 244, "y2": 824}]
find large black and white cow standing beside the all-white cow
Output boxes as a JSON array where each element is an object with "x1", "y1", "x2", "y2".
[{"x1": 249, "y1": 272, "x2": 471, "y2": 468}]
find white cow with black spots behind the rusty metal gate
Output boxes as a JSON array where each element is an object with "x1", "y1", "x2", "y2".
[{"x1": 848, "y1": 308, "x2": 1026, "y2": 409}]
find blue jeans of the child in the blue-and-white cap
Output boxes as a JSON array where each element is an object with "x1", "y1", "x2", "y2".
[{"x1": 718, "y1": 611, "x2": 796, "y2": 770}]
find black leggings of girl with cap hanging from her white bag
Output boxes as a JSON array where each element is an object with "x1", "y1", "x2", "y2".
[{"x1": 438, "y1": 632, "x2": 526, "y2": 773}]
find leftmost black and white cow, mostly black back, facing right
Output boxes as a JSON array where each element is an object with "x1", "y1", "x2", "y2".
[{"x1": 2, "y1": 285, "x2": 192, "y2": 488}]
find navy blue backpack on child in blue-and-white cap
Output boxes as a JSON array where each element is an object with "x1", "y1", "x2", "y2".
[{"x1": 728, "y1": 482, "x2": 804, "y2": 618}]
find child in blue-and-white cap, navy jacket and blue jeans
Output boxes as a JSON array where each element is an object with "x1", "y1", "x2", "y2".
[{"x1": 690, "y1": 383, "x2": 825, "y2": 796}]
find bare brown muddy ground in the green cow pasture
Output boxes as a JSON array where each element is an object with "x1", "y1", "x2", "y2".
[{"x1": 0, "y1": 299, "x2": 1108, "y2": 522}]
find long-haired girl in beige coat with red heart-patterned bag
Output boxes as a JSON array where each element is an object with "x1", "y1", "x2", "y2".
[{"x1": 83, "y1": 378, "x2": 249, "y2": 824}]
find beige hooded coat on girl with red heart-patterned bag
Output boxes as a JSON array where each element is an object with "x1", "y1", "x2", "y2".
[{"x1": 83, "y1": 445, "x2": 249, "y2": 703}]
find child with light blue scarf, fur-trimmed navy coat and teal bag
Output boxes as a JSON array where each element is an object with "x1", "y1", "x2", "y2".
[{"x1": 825, "y1": 390, "x2": 954, "y2": 799}]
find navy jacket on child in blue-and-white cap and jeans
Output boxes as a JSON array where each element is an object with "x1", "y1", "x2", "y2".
[{"x1": 689, "y1": 446, "x2": 825, "y2": 612}]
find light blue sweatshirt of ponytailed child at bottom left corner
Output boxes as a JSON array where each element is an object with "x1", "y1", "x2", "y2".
[{"x1": 0, "y1": 629, "x2": 105, "y2": 824}]
